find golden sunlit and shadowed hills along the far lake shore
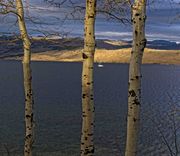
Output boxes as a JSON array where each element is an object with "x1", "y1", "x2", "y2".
[{"x1": 0, "y1": 38, "x2": 180, "y2": 65}]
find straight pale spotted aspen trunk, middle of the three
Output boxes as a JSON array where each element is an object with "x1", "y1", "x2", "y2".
[{"x1": 81, "y1": 0, "x2": 96, "y2": 156}]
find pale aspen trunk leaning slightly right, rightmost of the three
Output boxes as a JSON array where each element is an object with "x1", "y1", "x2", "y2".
[{"x1": 125, "y1": 0, "x2": 146, "y2": 156}]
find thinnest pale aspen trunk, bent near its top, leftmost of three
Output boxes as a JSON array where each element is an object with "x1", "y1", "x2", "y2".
[{"x1": 16, "y1": 0, "x2": 34, "y2": 156}]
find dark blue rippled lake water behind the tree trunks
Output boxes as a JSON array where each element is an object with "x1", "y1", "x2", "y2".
[{"x1": 0, "y1": 61, "x2": 180, "y2": 156}]
